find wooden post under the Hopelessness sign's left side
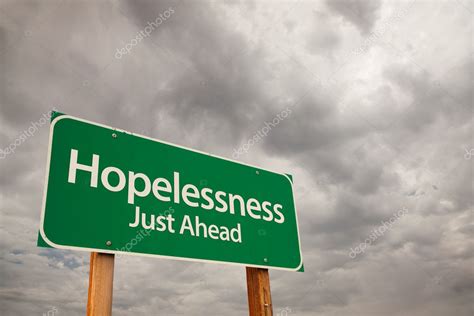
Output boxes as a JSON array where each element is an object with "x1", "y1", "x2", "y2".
[{"x1": 87, "y1": 252, "x2": 115, "y2": 316}]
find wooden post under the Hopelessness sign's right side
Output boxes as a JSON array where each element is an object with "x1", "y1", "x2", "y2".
[{"x1": 246, "y1": 267, "x2": 273, "y2": 316}]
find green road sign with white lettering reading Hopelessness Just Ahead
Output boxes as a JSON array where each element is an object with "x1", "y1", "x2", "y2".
[{"x1": 39, "y1": 113, "x2": 303, "y2": 270}]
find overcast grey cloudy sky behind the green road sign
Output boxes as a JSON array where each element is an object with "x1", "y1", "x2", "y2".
[{"x1": 0, "y1": 0, "x2": 474, "y2": 316}]
